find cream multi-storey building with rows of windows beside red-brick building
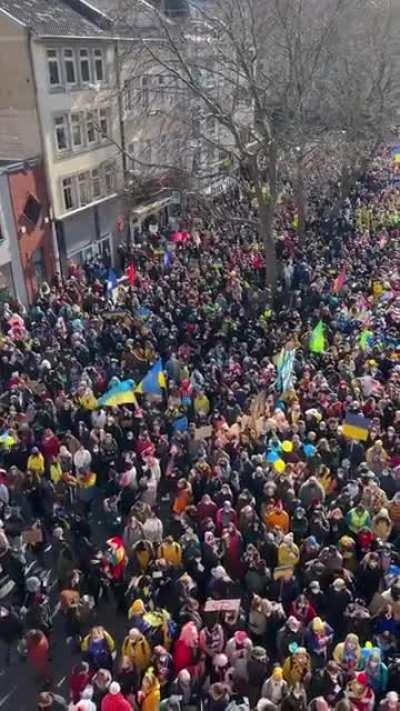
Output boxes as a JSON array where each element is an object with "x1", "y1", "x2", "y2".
[{"x1": 0, "y1": 0, "x2": 126, "y2": 269}]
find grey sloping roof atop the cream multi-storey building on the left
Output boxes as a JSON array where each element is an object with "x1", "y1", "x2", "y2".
[{"x1": 0, "y1": 0, "x2": 111, "y2": 38}]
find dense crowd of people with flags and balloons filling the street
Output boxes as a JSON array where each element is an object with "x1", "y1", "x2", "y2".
[{"x1": 0, "y1": 161, "x2": 400, "y2": 711}]
